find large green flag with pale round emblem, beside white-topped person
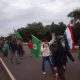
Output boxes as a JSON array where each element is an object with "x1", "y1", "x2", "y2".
[{"x1": 32, "y1": 35, "x2": 41, "y2": 57}]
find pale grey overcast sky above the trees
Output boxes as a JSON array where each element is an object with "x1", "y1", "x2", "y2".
[{"x1": 0, "y1": 0, "x2": 80, "y2": 36}]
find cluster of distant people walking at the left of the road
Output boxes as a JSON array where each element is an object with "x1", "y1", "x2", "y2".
[{"x1": 0, "y1": 37, "x2": 24, "y2": 64}]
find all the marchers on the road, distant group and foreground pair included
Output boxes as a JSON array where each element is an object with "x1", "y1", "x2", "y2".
[{"x1": 0, "y1": 34, "x2": 76, "y2": 80}]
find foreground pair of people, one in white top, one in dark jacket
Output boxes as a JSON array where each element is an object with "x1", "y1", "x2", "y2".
[{"x1": 41, "y1": 32, "x2": 76, "y2": 80}]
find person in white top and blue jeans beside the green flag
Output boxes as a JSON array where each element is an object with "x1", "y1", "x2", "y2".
[{"x1": 41, "y1": 40, "x2": 53, "y2": 74}]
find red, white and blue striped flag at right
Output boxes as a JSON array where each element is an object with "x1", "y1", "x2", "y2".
[{"x1": 65, "y1": 24, "x2": 74, "y2": 49}]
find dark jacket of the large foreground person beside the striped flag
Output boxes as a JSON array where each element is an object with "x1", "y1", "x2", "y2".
[{"x1": 52, "y1": 41, "x2": 74, "y2": 66}]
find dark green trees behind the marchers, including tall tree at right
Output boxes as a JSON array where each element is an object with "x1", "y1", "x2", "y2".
[{"x1": 17, "y1": 8, "x2": 80, "y2": 44}]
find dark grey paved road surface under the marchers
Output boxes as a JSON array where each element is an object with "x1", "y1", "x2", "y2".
[{"x1": 3, "y1": 47, "x2": 80, "y2": 80}]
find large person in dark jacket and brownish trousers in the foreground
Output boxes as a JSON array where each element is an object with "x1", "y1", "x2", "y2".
[{"x1": 52, "y1": 38, "x2": 75, "y2": 80}]
